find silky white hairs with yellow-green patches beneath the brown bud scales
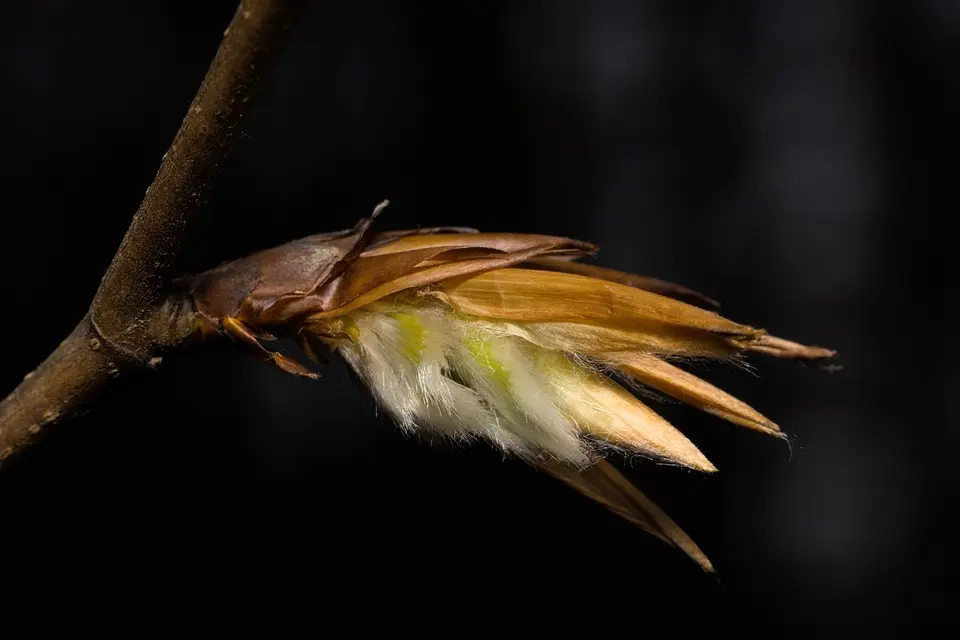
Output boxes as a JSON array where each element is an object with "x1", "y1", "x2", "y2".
[{"x1": 339, "y1": 306, "x2": 593, "y2": 466}]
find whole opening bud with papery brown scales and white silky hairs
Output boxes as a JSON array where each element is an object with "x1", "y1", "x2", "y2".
[{"x1": 186, "y1": 205, "x2": 834, "y2": 569}]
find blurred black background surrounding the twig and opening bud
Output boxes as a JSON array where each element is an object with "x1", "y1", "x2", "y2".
[{"x1": 0, "y1": 0, "x2": 960, "y2": 637}]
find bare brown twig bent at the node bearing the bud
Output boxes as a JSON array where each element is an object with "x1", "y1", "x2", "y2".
[{"x1": 0, "y1": 0, "x2": 306, "y2": 468}]
